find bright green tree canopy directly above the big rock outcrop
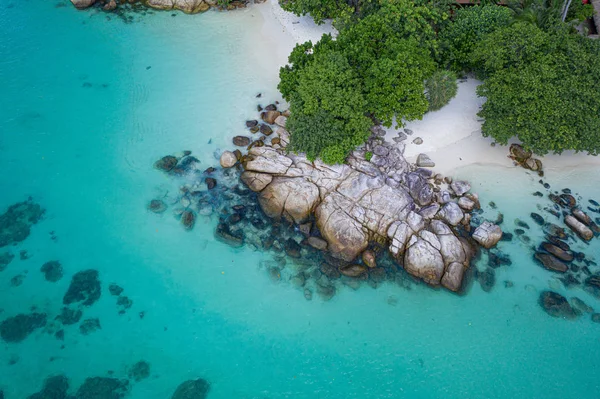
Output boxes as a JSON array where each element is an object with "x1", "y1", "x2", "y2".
[{"x1": 279, "y1": 0, "x2": 445, "y2": 163}]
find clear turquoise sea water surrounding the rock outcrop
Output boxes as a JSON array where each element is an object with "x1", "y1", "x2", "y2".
[{"x1": 0, "y1": 0, "x2": 600, "y2": 399}]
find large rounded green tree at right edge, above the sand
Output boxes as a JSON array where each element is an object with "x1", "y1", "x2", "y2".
[{"x1": 473, "y1": 22, "x2": 600, "y2": 155}]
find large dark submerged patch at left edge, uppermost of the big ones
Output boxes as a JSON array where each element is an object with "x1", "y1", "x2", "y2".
[{"x1": 0, "y1": 198, "x2": 45, "y2": 248}]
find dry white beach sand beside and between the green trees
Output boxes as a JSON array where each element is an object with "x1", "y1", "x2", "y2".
[{"x1": 255, "y1": 0, "x2": 600, "y2": 180}]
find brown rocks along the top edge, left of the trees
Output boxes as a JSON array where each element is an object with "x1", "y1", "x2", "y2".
[{"x1": 71, "y1": 0, "x2": 252, "y2": 14}]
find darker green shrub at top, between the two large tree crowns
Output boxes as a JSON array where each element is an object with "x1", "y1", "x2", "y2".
[{"x1": 439, "y1": 5, "x2": 512, "y2": 71}]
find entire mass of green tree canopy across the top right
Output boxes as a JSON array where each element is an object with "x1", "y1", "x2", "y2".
[{"x1": 279, "y1": 0, "x2": 600, "y2": 163}]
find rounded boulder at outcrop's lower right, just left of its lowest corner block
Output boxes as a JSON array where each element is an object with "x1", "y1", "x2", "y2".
[{"x1": 404, "y1": 236, "x2": 444, "y2": 285}]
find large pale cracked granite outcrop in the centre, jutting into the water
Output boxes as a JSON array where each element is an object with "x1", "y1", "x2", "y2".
[{"x1": 221, "y1": 119, "x2": 502, "y2": 291}]
